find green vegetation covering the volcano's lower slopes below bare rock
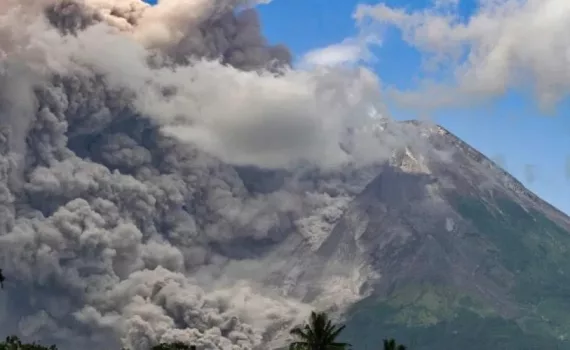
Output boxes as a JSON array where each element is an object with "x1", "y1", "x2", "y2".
[{"x1": 336, "y1": 197, "x2": 570, "y2": 350}]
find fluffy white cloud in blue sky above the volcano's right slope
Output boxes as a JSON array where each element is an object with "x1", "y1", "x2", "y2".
[{"x1": 355, "y1": 0, "x2": 570, "y2": 107}]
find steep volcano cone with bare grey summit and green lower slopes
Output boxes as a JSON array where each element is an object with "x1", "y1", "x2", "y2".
[{"x1": 317, "y1": 121, "x2": 570, "y2": 350}]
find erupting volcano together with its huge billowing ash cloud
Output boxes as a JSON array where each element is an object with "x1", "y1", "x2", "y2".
[{"x1": 0, "y1": 0, "x2": 570, "y2": 350}]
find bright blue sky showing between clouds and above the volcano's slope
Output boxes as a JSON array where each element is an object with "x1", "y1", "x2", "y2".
[{"x1": 141, "y1": 0, "x2": 570, "y2": 213}]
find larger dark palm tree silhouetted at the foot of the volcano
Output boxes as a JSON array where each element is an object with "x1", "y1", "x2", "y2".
[{"x1": 289, "y1": 311, "x2": 350, "y2": 350}]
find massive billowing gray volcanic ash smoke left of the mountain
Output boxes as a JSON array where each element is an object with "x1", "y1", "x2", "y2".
[{"x1": 0, "y1": 0, "x2": 412, "y2": 349}]
